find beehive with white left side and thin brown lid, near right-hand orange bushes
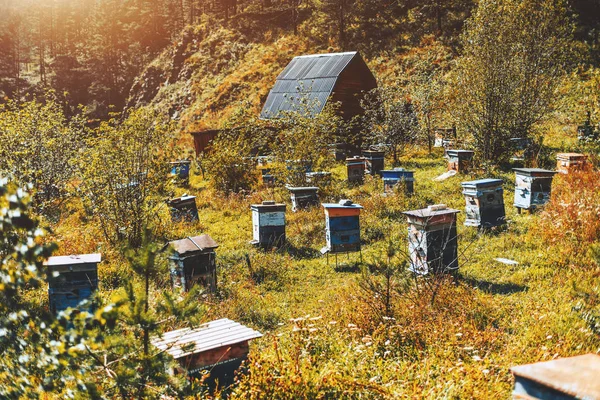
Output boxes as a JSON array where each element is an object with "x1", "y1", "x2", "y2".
[{"x1": 513, "y1": 168, "x2": 556, "y2": 212}]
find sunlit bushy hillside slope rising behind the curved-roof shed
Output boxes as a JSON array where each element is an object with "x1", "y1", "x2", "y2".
[{"x1": 126, "y1": 11, "x2": 452, "y2": 132}]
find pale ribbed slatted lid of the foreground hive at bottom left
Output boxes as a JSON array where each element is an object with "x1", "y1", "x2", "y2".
[{"x1": 152, "y1": 318, "x2": 262, "y2": 359}]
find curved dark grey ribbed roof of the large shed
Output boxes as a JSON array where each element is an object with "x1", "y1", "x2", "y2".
[{"x1": 260, "y1": 51, "x2": 357, "y2": 118}]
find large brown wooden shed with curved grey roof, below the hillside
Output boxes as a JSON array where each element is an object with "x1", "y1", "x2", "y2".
[{"x1": 260, "y1": 51, "x2": 377, "y2": 119}]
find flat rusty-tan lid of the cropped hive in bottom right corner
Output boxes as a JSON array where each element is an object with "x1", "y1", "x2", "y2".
[{"x1": 510, "y1": 354, "x2": 600, "y2": 399}]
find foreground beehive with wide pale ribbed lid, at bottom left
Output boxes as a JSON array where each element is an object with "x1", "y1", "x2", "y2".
[{"x1": 152, "y1": 318, "x2": 262, "y2": 387}]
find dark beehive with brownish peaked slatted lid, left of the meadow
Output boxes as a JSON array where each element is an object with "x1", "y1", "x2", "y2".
[{"x1": 169, "y1": 235, "x2": 219, "y2": 292}]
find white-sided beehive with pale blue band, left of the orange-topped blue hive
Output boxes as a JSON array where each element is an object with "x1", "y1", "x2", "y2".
[{"x1": 250, "y1": 201, "x2": 286, "y2": 247}]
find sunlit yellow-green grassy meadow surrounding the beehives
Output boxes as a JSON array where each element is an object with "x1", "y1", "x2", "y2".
[{"x1": 27, "y1": 124, "x2": 600, "y2": 399}]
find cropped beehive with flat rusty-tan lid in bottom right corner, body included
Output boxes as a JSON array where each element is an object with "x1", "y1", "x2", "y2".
[{"x1": 511, "y1": 354, "x2": 600, "y2": 400}]
